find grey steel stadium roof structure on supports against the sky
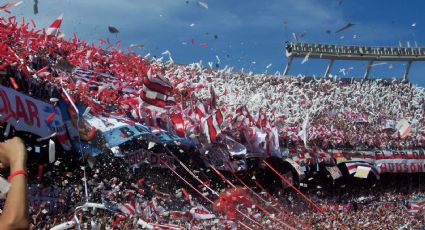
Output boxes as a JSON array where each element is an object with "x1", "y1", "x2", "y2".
[{"x1": 284, "y1": 42, "x2": 425, "y2": 81}]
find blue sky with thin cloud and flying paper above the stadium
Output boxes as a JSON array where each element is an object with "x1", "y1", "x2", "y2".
[{"x1": 0, "y1": 0, "x2": 425, "y2": 87}]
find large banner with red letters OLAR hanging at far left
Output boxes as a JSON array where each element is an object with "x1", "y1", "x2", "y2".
[{"x1": 0, "y1": 85, "x2": 71, "y2": 150}]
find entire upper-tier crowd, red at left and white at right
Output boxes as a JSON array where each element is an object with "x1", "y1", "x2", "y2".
[{"x1": 1, "y1": 14, "x2": 425, "y2": 149}]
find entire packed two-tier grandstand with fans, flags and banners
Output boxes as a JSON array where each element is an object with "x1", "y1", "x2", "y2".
[{"x1": 0, "y1": 8, "x2": 425, "y2": 229}]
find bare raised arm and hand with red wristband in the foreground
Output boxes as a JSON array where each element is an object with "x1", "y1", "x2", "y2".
[{"x1": 0, "y1": 137, "x2": 29, "y2": 229}]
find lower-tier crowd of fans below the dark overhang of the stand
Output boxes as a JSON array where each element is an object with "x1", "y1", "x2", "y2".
[{"x1": 2, "y1": 154, "x2": 425, "y2": 229}]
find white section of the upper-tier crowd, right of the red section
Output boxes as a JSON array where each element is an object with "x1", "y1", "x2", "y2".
[{"x1": 175, "y1": 71, "x2": 425, "y2": 149}]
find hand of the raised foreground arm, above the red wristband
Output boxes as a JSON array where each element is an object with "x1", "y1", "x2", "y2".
[{"x1": 0, "y1": 137, "x2": 27, "y2": 170}]
